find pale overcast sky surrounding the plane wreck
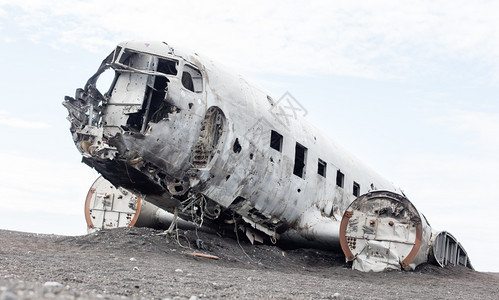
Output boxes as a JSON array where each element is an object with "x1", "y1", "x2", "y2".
[{"x1": 0, "y1": 0, "x2": 499, "y2": 272}]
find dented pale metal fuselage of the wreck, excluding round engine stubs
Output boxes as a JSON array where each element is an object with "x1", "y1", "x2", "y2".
[{"x1": 63, "y1": 41, "x2": 472, "y2": 272}]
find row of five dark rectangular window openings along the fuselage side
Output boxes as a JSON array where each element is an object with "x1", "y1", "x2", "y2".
[{"x1": 270, "y1": 130, "x2": 360, "y2": 197}]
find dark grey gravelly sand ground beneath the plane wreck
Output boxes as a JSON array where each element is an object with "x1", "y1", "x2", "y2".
[{"x1": 0, "y1": 228, "x2": 499, "y2": 300}]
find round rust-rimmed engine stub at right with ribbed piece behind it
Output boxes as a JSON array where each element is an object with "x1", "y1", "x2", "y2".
[{"x1": 340, "y1": 191, "x2": 471, "y2": 272}]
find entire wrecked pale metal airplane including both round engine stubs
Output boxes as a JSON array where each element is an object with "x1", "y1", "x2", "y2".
[{"x1": 63, "y1": 41, "x2": 472, "y2": 271}]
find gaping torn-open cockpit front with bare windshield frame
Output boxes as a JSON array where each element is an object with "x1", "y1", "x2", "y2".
[{"x1": 94, "y1": 46, "x2": 179, "y2": 134}]
